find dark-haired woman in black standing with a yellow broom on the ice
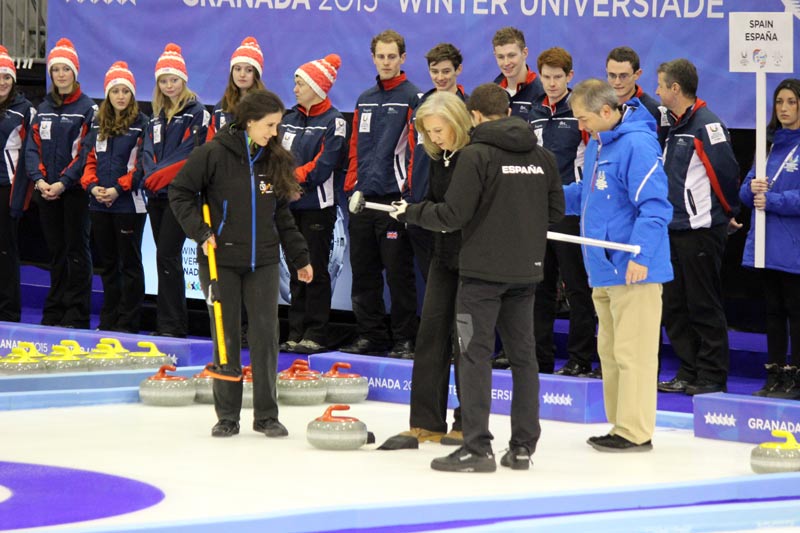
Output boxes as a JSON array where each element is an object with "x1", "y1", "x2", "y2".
[{"x1": 169, "y1": 90, "x2": 313, "y2": 437}]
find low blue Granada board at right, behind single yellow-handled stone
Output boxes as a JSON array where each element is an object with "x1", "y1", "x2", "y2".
[{"x1": 694, "y1": 393, "x2": 800, "y2": 444}]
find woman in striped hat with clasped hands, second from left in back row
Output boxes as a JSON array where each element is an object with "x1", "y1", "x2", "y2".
[{"x1": 25, "y1": 39, "x2": 97, "y2": 328}]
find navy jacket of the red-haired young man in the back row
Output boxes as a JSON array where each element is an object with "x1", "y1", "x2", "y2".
[{"x1": 528, "y1": 91, "x2": 589, "y2": 185}]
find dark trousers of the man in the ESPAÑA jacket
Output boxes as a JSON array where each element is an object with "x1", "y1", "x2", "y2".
[{"x1": 456, "y1": 276, "x2": 541, "y2": 454}]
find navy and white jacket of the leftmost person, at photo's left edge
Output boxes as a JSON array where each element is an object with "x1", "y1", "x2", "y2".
[{"x1": 0, "y1": 93, "x2": 36, "y2": 218}]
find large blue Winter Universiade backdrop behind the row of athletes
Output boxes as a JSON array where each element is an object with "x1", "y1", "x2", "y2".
[{"x1": 48, "y1": 0, "x2": 800, "y2": 128}]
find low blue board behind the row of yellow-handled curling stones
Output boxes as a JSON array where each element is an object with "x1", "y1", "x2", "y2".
[{"x1": 0, "y1": 322, "x2": 213, "y2": 366}]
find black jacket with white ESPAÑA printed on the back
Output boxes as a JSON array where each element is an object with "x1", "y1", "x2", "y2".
[{"x1": 406, "y1": 117, "x2": 564, "y2": 283}]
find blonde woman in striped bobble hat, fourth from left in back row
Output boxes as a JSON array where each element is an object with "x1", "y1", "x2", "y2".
[{"x1": 142, "y1": 43, "x2": 210, "y2": 337}]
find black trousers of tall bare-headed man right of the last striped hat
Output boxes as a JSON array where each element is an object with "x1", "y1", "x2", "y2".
[{"x1": 348, "y1": 201, "x2": 417, "y2": 344}]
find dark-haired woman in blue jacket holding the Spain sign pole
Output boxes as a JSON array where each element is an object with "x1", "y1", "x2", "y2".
[{"x1": 739, "y1": 79, "x2": 800, "y2": 399}]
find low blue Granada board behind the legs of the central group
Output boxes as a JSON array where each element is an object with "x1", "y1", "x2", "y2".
[{"x1": 308, "y1": 352, "x2": 606, "y2": 424}]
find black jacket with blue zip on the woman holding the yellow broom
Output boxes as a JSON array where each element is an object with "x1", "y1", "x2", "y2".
[{"x1": 169, "y1": 127, "x2": 309, "y2": 269}]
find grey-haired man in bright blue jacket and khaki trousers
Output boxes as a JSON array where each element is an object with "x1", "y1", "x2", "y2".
[{"x1": 564, "y1": 79, "x2": 672, "y2": 452}]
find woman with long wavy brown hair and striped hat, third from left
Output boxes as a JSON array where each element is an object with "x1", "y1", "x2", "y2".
[{"x1": 81, "y1": 61, "x2": 148, "y2": 333}]
